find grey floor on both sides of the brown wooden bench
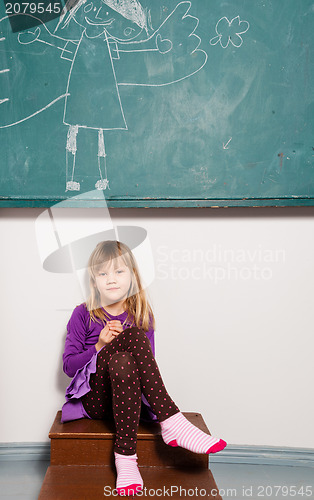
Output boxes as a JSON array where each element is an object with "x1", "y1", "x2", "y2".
[{"x1": 0, "y1": 460, "x2": 314, "y2": 500}]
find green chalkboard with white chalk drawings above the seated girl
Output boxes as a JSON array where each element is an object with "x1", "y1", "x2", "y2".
[{"x1": 0, "y1": 0, "x2": 314, "y2": 206}]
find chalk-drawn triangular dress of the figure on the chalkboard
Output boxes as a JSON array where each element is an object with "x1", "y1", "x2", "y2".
[{"x1": 63, "y1": 30, "x2": 127, "y2": 130}]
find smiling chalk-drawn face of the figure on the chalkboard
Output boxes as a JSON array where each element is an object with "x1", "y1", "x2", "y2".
[{"x1": 75, "y1": 0, "x2": 142, "y2": 41}]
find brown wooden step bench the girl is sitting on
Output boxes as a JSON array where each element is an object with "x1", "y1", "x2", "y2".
[{"x1": 39, "y1": 411, "x2": 221, "y2": 500}]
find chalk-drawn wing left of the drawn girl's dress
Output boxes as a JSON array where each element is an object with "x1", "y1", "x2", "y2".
[{"x1": 0, "y1": 16, "x2": 74, "y2": 129}]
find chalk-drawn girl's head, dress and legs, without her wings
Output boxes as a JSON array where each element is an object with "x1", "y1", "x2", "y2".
[{"x1": 63, "y1": 0, "x2": 152, "y2": 190}]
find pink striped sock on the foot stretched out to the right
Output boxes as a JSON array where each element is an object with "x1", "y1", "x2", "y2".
[{"x1": 160, "y1": 412, "x2": 227, "y2": 453}]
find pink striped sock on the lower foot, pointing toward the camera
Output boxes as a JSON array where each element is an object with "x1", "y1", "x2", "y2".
[{"x1": 114, "y1": 452, "x2": 143, "y2": 496}]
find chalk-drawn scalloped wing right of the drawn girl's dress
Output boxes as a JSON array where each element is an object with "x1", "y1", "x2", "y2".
[{"x1": 111, "y1": 1, "x2": 207, "y2": 86}]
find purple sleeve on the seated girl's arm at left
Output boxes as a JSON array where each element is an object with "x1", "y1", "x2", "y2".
[{"x1": 63, "y1": 306, "x2": 97, "y2": 377}]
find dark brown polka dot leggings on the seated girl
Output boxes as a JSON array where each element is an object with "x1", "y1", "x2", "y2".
[{"x1": 82, "y1": 327, "x2": 180, "y2": 455}]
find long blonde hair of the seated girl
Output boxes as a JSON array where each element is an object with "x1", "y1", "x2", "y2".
[{"x1": 86, "y1": 240, "x2": 155, "y2": 331}]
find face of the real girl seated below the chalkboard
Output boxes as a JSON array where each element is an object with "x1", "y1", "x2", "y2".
[{"x1": 95, "y1": 257, "x2": 131, "y2": 307}]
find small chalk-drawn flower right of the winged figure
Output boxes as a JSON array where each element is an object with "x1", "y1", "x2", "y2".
[{"x1": 209, "y1": 16, "x2": 250, "y2": 49}]
